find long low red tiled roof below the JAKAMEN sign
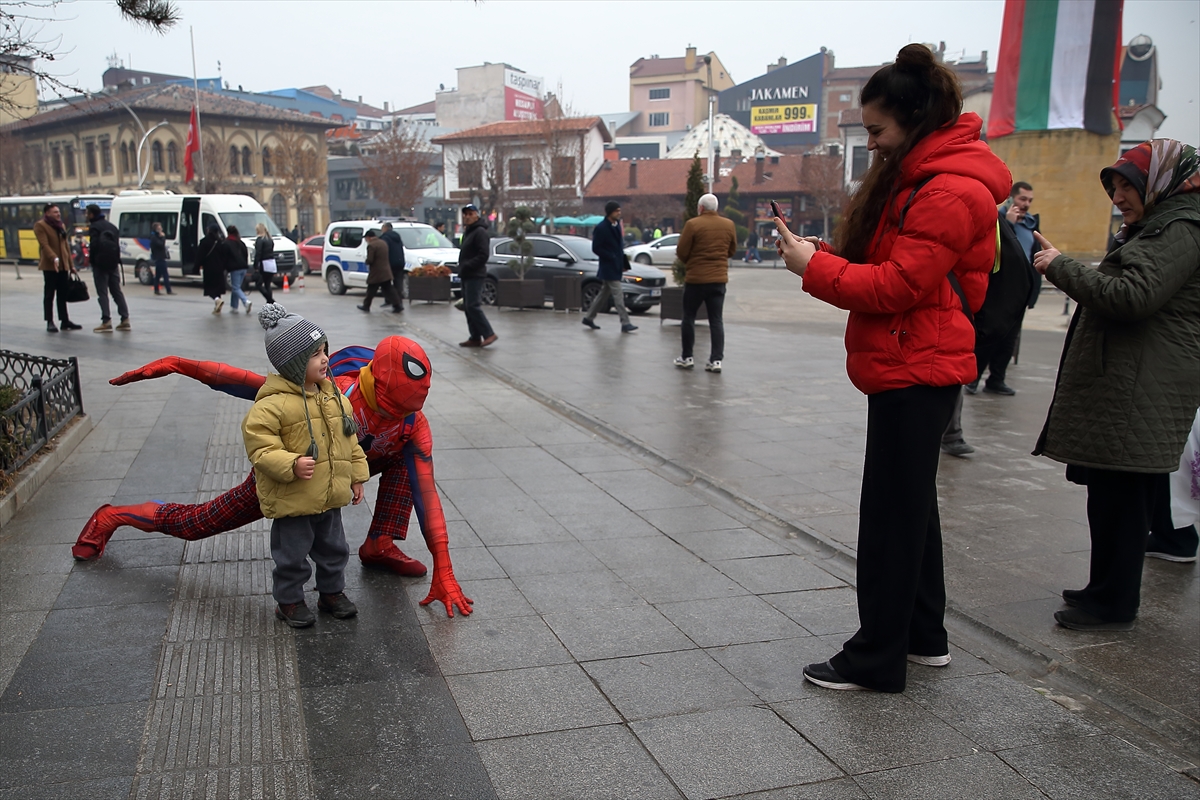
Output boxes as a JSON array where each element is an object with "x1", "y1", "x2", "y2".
[{"x1": 583, "y1": 156, "x2": 804, "y2": 198}]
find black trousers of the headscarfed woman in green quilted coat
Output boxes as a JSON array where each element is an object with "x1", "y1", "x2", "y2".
[{"x1": 1080, "y1": 468, "x2": 1169, "y2": 622}]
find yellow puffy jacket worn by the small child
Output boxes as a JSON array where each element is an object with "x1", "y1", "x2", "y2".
[{"x1": 241, "y1": 374, "x2": 370, "y2": 519}]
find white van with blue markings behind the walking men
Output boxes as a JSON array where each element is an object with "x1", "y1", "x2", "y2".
[{"x1": 320, "y1": 219, "x2": 458, "y2": 294}]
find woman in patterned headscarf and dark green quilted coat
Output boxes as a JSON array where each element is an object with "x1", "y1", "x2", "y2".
[{"x1": 1033, "y1": 139, "x2": 1200, "y2": 631}]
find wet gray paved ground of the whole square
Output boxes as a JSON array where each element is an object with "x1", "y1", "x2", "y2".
[{"x1": 0, "y1": 267, "x2": 1200, "y2": 799}]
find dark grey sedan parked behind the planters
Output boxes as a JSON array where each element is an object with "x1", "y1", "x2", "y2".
[{"x1": 484, "y1": 234, "x2": 666, "y2": 314}]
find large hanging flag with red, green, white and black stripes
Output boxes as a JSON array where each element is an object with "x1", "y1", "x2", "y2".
[{"x1": 988, "y1": 0, "x2": 1123, "y2": 138}]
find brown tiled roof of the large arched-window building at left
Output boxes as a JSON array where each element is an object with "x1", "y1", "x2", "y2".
[{"x1": 0, "y1": 84, "x2": 329, "y2": 132}]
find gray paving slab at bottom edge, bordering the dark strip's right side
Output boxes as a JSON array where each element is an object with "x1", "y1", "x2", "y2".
[{"x1": 476, "y1": 724, "x2": 682, "y2": 800}]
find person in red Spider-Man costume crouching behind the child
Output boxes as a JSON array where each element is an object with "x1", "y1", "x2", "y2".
[{"x1": 71, "y1": 336, "x2": 472, "y2": 616}]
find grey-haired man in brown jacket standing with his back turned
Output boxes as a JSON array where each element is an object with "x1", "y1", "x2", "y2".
[{"x1": 674, "y1": 194, "x2": 738, "y2": 372}]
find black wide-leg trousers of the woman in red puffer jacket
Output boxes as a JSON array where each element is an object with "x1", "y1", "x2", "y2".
[{"x1": 833, "y1": 386, "x2": 962, "y2": 692}]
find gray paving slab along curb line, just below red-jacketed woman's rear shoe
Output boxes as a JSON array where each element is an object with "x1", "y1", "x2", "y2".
[{"x1": 907, "y1": 662, "x2": 1098, "y2": 751}]
